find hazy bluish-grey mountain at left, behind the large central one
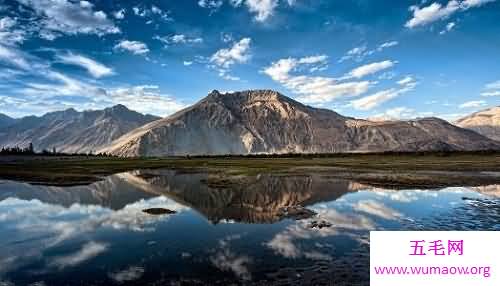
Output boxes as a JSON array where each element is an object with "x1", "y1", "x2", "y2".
[{"x1": 0, "y1": 105, "x2": 159, "y2": 153}]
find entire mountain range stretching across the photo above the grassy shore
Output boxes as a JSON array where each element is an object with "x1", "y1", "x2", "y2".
[{"x1": 0, "y1": 90, "x2": 500, "y2": 157}]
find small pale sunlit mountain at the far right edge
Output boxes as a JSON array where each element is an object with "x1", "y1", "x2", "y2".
[{"x1": 455, "y1": 106, "x2": 500, "y2": 141}]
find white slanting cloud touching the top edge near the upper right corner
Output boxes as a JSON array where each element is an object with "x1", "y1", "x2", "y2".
[{"x1": 405, "y1": 0, "x2": 496, "y2": 28}]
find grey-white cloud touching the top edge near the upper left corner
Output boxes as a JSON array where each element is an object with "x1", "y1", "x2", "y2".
[{"x1": 17, "y1": 0, "x2": 120, "y2": 40}]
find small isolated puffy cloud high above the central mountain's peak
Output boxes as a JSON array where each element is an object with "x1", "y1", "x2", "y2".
[{"x1": 209, "y1": 38, "x2": 252, "y2": 80}]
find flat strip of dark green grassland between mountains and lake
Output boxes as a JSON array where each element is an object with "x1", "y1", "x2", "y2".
[{"x1": 0, "y1": 153, "x2": 500, "y2": 186}]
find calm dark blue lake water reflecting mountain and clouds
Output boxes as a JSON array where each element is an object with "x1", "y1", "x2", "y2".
[{"x1": 0, "y1": 170, "x2": 500, "y2": 286}]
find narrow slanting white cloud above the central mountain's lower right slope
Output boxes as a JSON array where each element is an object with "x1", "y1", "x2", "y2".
[{"x1": 351, "y1": 76, "x2": 417, "y2": 110}]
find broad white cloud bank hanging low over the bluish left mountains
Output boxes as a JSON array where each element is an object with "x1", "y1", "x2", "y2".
[{"x1": 5, "y1": 61, "x2": 185, "y2": 116}]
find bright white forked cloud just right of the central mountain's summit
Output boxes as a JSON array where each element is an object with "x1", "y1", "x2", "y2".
[{"x1": 263, "y1": 55, "x2": 371, "y2": 103}]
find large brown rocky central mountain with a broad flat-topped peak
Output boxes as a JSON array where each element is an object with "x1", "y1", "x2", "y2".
[{"x1": 102, "y1": 90, "x2": 500, "y2": 157}]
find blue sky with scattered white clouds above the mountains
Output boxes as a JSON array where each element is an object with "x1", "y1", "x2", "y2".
[{"x1": 0, "y1": 0, "x2": 500, "y2": 119}]
